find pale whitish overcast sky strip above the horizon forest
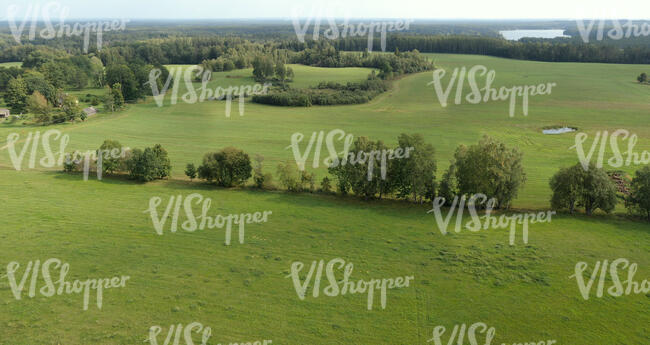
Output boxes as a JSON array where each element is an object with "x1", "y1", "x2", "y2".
[{"x1": 0, "y1": 0, "x2": 650, "y2": 21}]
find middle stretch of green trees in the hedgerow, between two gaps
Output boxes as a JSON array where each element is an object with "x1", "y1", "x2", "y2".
[{"x1": 185, "y1": 134, "x2": 525, "y2": 208}]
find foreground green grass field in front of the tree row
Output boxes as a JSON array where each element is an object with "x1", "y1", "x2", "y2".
[{"x1": 0, "y1": 168, "x2": 650, "y2": 345}]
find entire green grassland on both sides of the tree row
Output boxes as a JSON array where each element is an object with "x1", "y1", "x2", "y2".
[{"x1": 0, "y1": 54, "x2": 650, "y2": 345}]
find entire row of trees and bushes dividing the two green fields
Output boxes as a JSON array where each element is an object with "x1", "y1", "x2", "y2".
[{"x1": 58, "y1": 133, "x2": 650, "y2": 221}]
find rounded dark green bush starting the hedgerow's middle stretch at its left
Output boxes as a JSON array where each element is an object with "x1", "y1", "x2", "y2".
[{"x1": 198, "y1": 147, "x2": 253, "y2": 187}]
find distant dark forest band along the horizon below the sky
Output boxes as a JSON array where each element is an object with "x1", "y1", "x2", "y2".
[{"x1": 0, "y1": 22, "x2": 650, "y2": 67}]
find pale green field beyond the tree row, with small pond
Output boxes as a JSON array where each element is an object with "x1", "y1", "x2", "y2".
[{"x1": 0, "y1": 54, "x2": 650, "y2": 212}]
